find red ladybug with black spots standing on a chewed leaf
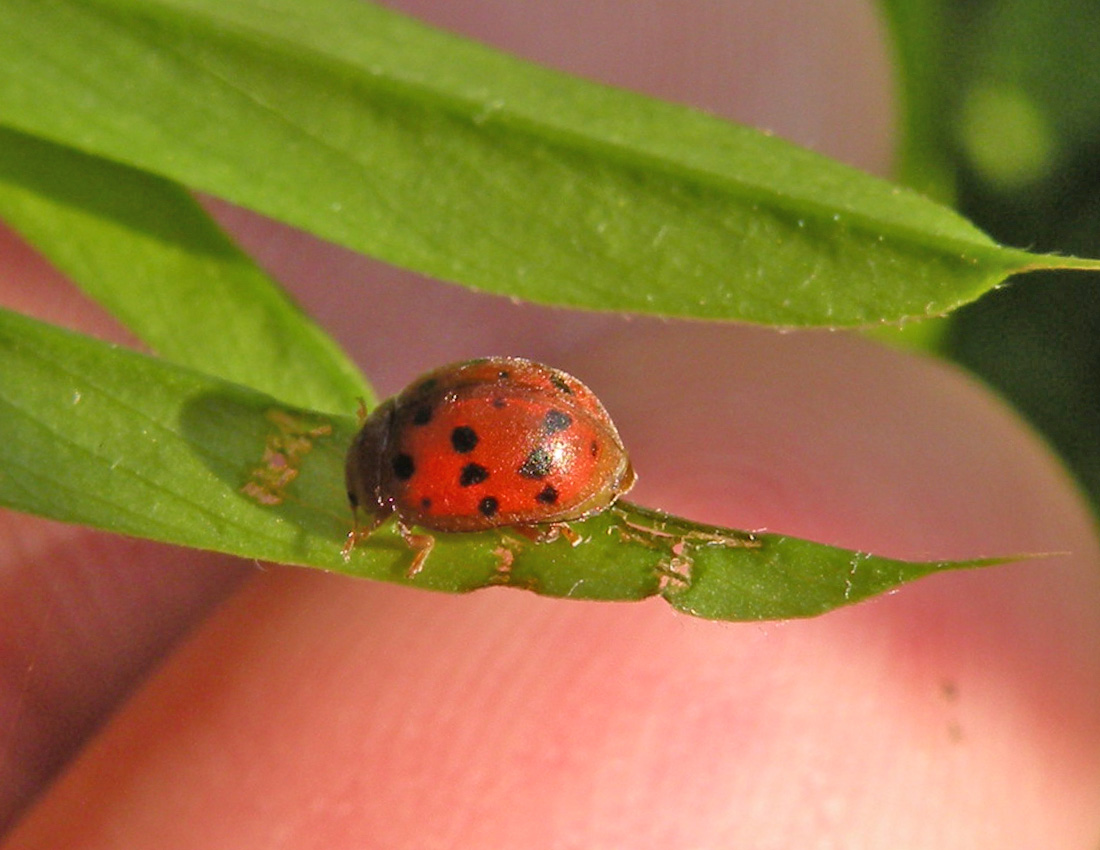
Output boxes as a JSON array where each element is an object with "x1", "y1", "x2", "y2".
[{"x1": 344, "y1": 357, "x2": 635, "y2": 575}]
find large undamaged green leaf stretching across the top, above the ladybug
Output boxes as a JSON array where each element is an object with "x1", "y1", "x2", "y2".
[{"x1": 0, "y1": 0, "x2": 1097, "y2": 327}]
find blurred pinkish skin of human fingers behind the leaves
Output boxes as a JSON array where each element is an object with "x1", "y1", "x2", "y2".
[{"x1": 0, "y1": 0, "x2": 1100, "y2": 850}]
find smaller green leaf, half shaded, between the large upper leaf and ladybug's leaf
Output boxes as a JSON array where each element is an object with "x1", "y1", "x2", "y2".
[{"x1": 0, "y1": 129, "x2": 370, "y2": 411}]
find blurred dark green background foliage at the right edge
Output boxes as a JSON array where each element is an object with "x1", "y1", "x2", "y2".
[{"x1": 883, "y1": 0, "x2": 1100, "y2": 504}]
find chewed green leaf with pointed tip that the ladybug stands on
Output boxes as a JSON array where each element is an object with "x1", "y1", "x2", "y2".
[{"x1": 0, "y1": 310, "x2": 1012, "y2": 619}]
